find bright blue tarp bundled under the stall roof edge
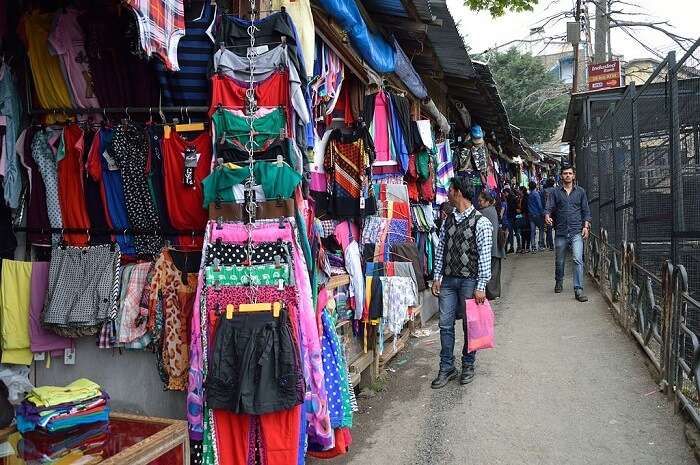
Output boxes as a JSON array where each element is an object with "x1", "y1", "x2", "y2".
[{"x1": 319, "y1": 0, "x2": 395, "y2": 73}]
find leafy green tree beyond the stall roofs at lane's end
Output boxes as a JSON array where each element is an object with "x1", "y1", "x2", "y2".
[{"x1": 487, "y1": 48, "x2": 569, "y2": 144}]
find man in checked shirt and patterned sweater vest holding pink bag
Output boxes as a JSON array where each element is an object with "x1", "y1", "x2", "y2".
[{"x1": 431, "y1": 178, "x2": 493, "y2": 389}]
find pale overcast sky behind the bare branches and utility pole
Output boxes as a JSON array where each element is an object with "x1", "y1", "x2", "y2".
[{"x1": 447, "y1": 0, "x2": 700, "y2": 64}]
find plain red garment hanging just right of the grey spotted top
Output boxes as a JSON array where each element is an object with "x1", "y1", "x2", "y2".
[{"x1": 58, "y1": 124, "x2": 90, "y2": 246}]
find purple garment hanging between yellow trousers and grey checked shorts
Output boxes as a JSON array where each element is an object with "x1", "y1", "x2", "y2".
[{"x1": 29, "y1": 262, "x2": 73, "y2": 356}]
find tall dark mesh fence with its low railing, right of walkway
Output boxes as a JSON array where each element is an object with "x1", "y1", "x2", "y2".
[{"x1": 576, "y1": 40, "x2": 700, "y2": 427}]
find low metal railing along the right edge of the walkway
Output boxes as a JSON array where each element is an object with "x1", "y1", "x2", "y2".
[{"x1": 585, "y1": 229, "x2": 700, "y2": 428}]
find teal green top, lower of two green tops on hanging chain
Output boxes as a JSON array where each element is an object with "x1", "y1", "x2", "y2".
[{"x1": 202, "y1": 161, "x2": 301, "y2": 208}]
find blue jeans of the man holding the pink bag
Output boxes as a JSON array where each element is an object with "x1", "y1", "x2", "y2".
[{"x1": 438, "y1": 276, "x2": 476, "y2": 373}]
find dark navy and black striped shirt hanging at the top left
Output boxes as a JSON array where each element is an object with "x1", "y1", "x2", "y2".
[{"x1": 154, "y1": 1, "x2": 216, "y2": 106}]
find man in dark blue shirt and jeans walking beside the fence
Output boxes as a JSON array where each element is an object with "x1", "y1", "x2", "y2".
[{"x1": 544, "y1": 165, "x2": 591, "y2": 302}]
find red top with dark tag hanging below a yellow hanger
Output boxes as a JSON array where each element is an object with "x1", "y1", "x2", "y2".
[{"x1": 162, "y1": 131, "x2": 212, "y2": 248}]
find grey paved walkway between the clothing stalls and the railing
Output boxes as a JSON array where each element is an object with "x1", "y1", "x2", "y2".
[{"x1": 326, "y1": 252, "x2": 696, "y2": 465}]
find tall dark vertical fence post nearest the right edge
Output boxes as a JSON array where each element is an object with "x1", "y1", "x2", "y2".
[{"x1": 668, "y1": 52, "x2": 685, "y2": 265}]
